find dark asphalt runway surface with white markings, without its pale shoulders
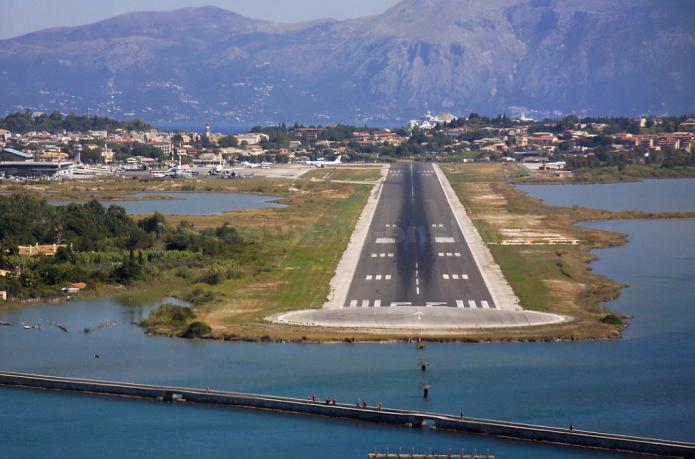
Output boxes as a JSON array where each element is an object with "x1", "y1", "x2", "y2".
[{"x1": 343, "y1": 163, "x2": 497, "y2": 309}]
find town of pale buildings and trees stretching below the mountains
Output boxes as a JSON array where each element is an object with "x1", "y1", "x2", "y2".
[{"x1": 0, "y1": 111, "x2": 695, "y2": 180}]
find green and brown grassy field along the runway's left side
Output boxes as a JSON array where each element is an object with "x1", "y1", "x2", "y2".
[{"x1": 149, "y1": 181, "x2": 371, "y2": 339}]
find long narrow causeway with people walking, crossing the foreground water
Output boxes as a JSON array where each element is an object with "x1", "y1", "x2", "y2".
[{"x1": 0, "y1": 372, "x2": 695, "y2": 458}]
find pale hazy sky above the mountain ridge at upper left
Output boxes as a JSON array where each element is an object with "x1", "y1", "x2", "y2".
[{"x1": 0, "y1": 0, "x2": 398, "y2": 39}]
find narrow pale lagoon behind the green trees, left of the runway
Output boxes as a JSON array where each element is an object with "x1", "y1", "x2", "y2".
[{"x1": 51, "y1": 191, "x2": 285, "y2": 215}]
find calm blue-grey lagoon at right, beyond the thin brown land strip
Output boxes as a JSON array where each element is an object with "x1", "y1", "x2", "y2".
[{"x1": 517, "y1": 179, "x2": 695, "y2": 212}]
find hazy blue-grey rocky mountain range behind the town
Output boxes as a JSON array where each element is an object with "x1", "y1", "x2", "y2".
[{"x1": 0, "y1": 0, "x2": 695, "y2": 124}]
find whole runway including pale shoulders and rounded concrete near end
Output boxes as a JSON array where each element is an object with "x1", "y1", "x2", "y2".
[{"x1": 268, "y1": 163, "x2": 570, "y2": 330}]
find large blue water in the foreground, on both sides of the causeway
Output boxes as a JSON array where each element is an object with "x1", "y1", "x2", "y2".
[{"x1": 0, "y1": 181, "x2": 695, "y2": 458}]
